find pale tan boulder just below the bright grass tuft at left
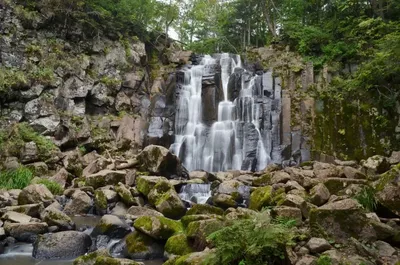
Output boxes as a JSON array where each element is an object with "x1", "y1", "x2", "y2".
[{"x1": 18, "y1": 184, "x2": 54, "y2": 205}]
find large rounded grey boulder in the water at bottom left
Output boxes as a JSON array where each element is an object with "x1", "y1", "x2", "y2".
[{"x1": 32, "y1": 231, "x2": 92, "y2": 260}]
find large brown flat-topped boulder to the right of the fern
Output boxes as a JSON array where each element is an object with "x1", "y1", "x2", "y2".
[{"x1": 310, "y1": 199, "x2": 377, "y2": 243}]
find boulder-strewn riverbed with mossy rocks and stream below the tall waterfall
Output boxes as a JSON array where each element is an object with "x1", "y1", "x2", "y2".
[{"x1": 0, "y1": 146, "x2": 400, "y2": 265}]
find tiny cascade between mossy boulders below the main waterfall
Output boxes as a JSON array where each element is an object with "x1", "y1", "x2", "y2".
[{"x1": 179, "y1": 184, "x2": 211, "y2": 204}]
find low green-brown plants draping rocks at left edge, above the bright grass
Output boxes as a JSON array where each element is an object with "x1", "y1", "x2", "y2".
[{"x1": 0, "y1": 123, "x2": 56, "y2": 159}]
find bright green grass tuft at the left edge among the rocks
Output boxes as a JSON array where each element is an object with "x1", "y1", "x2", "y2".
[{"x1": 0, "y1": 167, "x2": 33, "y2": 190}]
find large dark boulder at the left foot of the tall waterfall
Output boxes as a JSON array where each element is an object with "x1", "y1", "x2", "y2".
[{"x1": 137, "y1": 145, "x2": 189, "y2": 178}]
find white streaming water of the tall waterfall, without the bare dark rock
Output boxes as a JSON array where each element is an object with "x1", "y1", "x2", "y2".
[{"x1": 171, "y1": 54, "x2": 280, "y2": 172}]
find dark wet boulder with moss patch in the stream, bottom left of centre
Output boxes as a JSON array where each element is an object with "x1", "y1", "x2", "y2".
[{"x1": 124, "y1": 231, "x2": 164, "y2": 260}]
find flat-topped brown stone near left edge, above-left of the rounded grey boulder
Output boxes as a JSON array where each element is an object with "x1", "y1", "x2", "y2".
[{"x1": 4, "y1": 223, "x2": 48, "y2": 243}]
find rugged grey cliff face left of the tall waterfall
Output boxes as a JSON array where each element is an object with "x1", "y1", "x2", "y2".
[{"x1": 0, "y1": 1, "x2": 190, "y2": 163}]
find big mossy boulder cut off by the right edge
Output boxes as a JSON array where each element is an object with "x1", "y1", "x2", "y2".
[{"x1": 376, "y1": 164, "x2": 400, "y2": 216}]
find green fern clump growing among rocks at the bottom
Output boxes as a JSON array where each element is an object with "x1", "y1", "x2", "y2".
[{"x1": 206, "y1": 212, "x2": 294, "y2": 265}]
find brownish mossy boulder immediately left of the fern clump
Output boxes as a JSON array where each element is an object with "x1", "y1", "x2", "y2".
[{"x1": 186, "y1": 219, "x2": 224, "y2": 250}]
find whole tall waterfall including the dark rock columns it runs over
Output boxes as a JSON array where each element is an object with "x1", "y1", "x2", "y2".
[{"x1": 171, "y1": 53, "x2": 281, "y2": 172}]
